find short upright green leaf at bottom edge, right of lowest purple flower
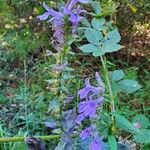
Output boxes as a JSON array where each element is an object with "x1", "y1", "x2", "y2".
[{"x1": 108, "y1": 135, "x2": 117, "y2": 150}]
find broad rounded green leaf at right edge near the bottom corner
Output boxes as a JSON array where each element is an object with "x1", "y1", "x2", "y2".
[{"x1": 133, "y1": 129, "x2": 150, "y2": 144}]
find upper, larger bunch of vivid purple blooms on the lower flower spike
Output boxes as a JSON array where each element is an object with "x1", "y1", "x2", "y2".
[{"x1": 76, "y1": 72, "x2": 104, "y2": 123}]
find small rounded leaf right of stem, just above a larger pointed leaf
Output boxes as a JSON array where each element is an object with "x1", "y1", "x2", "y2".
[{"x1": 110, "y1": 70, "x2": 125, "y2": 81}]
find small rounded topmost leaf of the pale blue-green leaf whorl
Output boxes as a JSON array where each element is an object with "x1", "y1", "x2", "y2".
[{"x1": 91, "y1": 18, "x2": 105, "y2": 29}]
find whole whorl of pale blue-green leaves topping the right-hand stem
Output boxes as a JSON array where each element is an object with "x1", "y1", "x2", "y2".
[{"x1": 80, "y1": 18, "x2": 122, "y2": 57}]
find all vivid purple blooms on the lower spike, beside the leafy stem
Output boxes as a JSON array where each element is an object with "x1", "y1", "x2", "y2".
[{"x1": 76, "y1": 72, "x2": 104, "y2": 150}]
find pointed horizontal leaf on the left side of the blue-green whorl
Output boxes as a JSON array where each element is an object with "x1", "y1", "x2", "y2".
[{"x1": 79, "y1": 44, "x2": 100, "y2": 53}]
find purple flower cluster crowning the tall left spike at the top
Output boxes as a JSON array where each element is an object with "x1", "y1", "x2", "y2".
[{"x1": 37, "y1": 0, "x2": 89, "y2": 50}]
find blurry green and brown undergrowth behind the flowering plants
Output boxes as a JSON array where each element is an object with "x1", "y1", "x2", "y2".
[{"x1": 0, "y1": 0, "x2": 150, "y2": 150}]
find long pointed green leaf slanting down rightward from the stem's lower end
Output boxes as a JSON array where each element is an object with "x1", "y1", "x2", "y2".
[{"x1": 113, "y1": 112, "x2": 139, "y2": 133}]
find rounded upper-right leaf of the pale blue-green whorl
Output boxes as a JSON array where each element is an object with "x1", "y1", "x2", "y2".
[{"x1": 107, "y1": 30, "x2": 121, "y2": 44}]
